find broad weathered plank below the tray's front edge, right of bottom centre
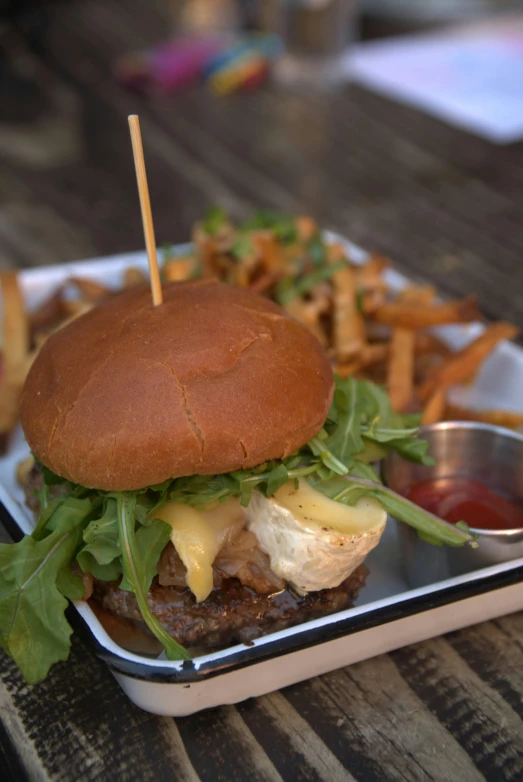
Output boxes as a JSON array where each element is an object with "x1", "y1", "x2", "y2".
[{"x1": 284, "y1": 655, "x2": 483, "y2": 782}]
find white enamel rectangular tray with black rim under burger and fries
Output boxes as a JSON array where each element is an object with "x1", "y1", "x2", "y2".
[{"x1": 0, "y1": 242, "x2": 523, "y2": 716}]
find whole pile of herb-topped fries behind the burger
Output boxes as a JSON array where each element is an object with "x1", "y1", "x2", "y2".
[{"x1": 0, "y1": 209, "x2": 523, "y2": 454}]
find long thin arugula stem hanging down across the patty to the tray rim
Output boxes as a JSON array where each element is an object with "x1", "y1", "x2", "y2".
[{"x1": 116, "y1": 492, "x2": 191, "y2": 660}]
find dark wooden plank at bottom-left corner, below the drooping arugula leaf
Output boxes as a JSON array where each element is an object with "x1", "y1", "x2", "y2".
[{"x1": 0, "y1": 635, "x2": 198, "y2": 782}]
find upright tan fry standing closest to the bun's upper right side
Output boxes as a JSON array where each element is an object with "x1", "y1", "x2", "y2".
[{"x1": 332, "y1": 266, "x2": 366, "y2": 362}]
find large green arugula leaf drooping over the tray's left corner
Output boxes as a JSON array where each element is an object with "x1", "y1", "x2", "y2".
[{"x1": 0, "y1": 498, "x2": 92, "y2": 684}]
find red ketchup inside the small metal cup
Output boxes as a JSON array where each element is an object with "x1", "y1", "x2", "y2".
[{"x1": 405, "y1": 478, "x2": 523, "y2": 530}]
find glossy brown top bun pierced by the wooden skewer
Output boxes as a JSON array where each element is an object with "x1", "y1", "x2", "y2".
[{"x1": 20, "y1": 280, "x2": 333, "y2": 491}]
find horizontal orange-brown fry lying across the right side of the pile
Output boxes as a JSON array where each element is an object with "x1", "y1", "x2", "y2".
[{"x1": 372, "y1": 296, "x2": 481, "y2": 329}]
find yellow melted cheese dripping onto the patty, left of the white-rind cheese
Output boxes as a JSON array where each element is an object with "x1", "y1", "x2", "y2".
[{"x1": 154, "y1": 498, "x2": 245, "y2": 603}]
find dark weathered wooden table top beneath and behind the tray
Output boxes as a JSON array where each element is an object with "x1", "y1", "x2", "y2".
[{"x1": 0, "y1": 0, "x2": 523, "y2": 782}]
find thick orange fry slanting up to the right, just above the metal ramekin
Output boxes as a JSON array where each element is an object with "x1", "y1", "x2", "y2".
[{"x1": 419, "y1": 322, "x2": 518, "y2": 400}]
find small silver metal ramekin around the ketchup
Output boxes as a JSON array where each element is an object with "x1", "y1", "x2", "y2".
[{"x1": 382, "y1": 421, "x2": 523, "y2": 587}]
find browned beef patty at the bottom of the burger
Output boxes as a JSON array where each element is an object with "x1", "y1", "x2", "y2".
[{"x1": 93, "y1": 565, "x2": 368, "y2": 649}]
